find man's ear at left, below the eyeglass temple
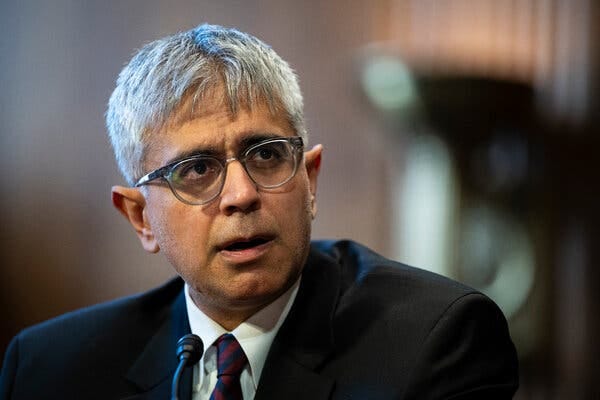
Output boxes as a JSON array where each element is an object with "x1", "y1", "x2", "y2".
[{"x1": 111, "y1": 186, "x2": 160, "y2": 253}]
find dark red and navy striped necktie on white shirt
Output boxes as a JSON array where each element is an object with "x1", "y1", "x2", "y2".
[{"x1": 210, "y1": 333, "x2": 248, "y2": 400}]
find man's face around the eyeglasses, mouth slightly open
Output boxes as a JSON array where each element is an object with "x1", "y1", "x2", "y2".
[{"x1": 131, "y1": 96, "x2": 321, "y2": 322}]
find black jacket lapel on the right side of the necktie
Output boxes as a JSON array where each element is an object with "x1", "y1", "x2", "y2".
[{"x1": 255, "y1": 249, "x2": 341, "y2": 400}]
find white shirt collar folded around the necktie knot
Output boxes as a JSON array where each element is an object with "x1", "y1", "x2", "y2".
[{"x1": 185, "y1": 278, "x2": 300, "y2": 388}]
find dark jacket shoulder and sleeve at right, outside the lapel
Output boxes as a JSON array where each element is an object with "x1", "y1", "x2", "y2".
[{"x1": 311, "y1": 241, "x2": 517, "y2": 399}]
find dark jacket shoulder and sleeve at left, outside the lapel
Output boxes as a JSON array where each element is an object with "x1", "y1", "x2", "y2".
[{"x1": 0, "y1": 279, "x2": 183, "y2": 399}]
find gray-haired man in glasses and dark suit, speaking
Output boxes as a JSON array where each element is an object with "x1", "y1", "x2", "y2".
[{"x1": 0, "y1": 25, "x2": 517, "y2": 400}]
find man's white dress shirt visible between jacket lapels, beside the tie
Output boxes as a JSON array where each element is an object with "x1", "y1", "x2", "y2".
[{"x1": 185, "y1": 279, "x2": 300, "y2": 400}]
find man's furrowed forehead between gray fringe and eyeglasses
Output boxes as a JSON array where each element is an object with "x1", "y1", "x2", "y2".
[{"x1": 145, "y1": 96, "x2": 294, "y2": 169}]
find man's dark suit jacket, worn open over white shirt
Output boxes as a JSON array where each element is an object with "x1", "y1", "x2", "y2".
[{"x1": 0, "y1": 241, "x2": 517, "y2": 400}]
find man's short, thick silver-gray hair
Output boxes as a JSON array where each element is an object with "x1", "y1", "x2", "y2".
[{"x1": 106, "y1": 24, "x2": 306, "y2": 185}]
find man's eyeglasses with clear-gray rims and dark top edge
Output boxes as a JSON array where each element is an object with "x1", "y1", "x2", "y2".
[{"x1": 135, "y1": 136, "x2": 304, "y2": 205}]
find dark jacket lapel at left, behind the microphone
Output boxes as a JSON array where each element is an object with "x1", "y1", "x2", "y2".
[{"x1": 126, "y1": 284, "x2": 193, "y2": 400}]
